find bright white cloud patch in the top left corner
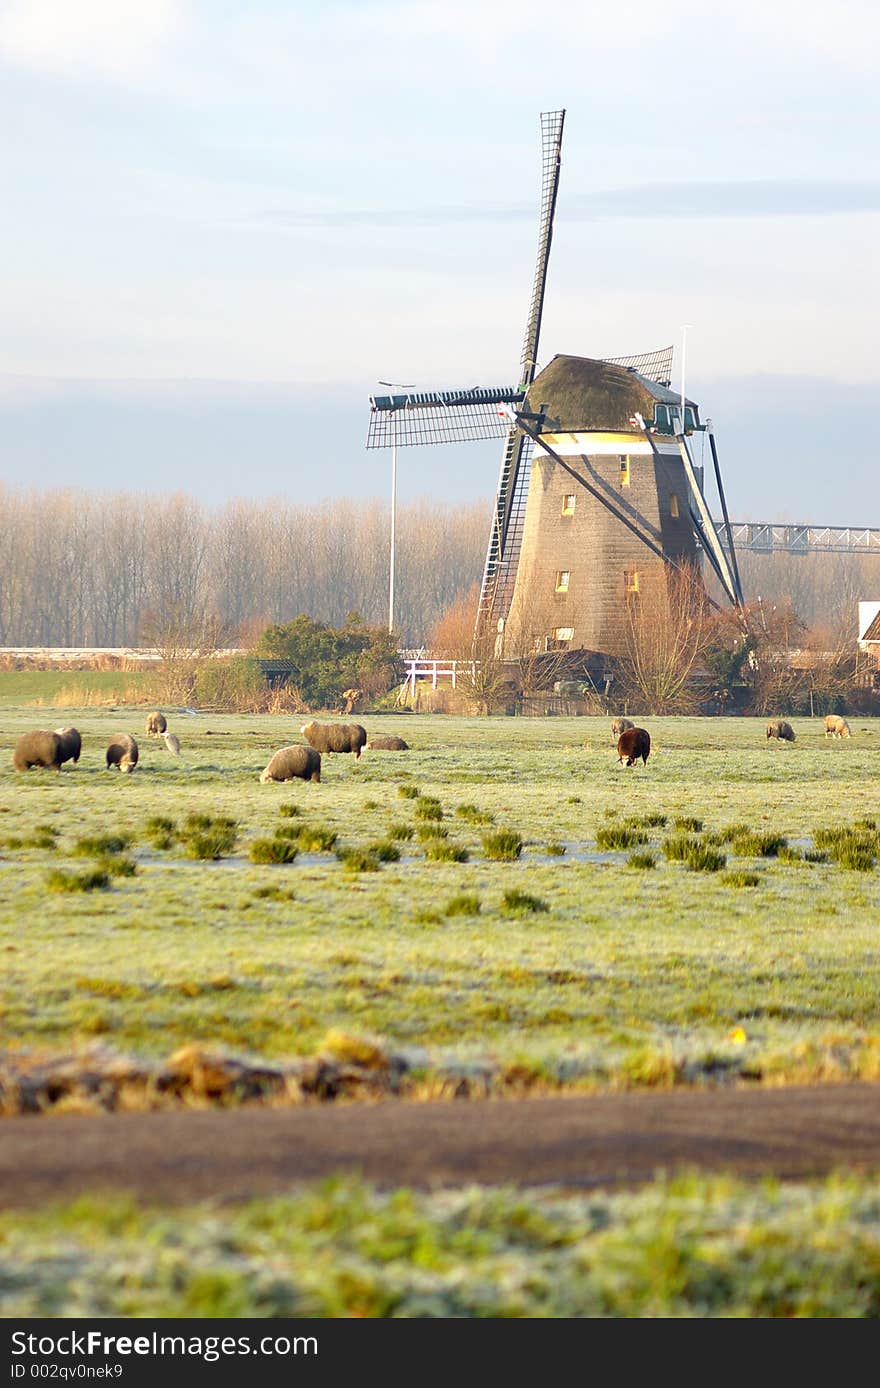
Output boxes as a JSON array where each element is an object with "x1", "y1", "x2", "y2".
[{"x1": 0, "y1": 0, "x2": 183, "y2": 79}]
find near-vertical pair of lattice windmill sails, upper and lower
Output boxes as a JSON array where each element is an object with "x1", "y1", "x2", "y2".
[{"x1": 477, "y1": 111, "x2": 565, "y2": 629}]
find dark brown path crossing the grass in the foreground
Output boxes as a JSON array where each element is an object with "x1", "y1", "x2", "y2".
[{"x1": 0, "y1": 1084, "x2": 880, "y2": 1208}]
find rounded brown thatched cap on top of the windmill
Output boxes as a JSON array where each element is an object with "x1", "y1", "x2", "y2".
[{"x1": 526, "y1": 355, "x2": 697, "y2": 433}]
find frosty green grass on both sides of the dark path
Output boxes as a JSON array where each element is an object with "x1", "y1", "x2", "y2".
[{"x1": 0, "y1": 705, "x2": 880, "y2": 1316}]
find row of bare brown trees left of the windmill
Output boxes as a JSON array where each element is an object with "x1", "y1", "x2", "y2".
[{"x1": 0, "y1": 487, "x2": 491, "y2": 647}]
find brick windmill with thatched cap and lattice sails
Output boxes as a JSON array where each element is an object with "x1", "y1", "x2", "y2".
[{"x1": 366, "y1": 111, "x2": 743, "y2": 655}]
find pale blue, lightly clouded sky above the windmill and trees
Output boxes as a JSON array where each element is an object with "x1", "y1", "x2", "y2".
[{"x1": 0, "y1": 0, "x2": 880, "y2": 526}]
